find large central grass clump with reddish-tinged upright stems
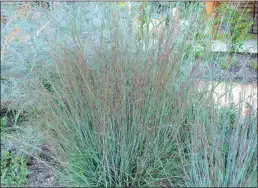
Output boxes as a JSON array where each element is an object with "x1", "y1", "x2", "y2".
[{"x1": 31, "y1": 4, "x2": 208, "y2": 187}]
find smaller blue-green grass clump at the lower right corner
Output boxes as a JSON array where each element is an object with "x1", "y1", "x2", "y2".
[{"x1": 179, "y1": 101, "x2": 257, "y2": 187}]
